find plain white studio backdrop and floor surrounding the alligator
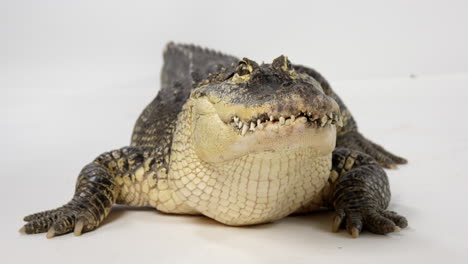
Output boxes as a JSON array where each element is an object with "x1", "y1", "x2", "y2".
[{"x1": 0, "y1": 0, "x2": 468, "y2": 263}]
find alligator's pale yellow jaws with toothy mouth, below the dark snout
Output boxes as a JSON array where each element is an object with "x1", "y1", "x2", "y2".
[{"x1": 192, "y1": 98, "x2": 342, "y2": 163}]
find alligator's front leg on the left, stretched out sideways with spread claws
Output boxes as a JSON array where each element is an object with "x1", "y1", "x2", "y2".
[{"x1": 20, "y1": 147, "x2": 149, "y2": 238}]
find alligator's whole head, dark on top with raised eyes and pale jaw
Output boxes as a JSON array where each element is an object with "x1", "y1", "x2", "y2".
[{"x1": 186, "y1": 56, "x2": 341, "y2": 162}]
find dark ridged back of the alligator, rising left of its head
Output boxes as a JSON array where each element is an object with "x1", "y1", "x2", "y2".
[{"x1": 131, "y1": 42, "x2": 238, "y2": 150}]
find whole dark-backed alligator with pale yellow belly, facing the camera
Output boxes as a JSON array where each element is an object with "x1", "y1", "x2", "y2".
[{"x1": 21, "y1": 43, "x2": 407, "y2": 238}]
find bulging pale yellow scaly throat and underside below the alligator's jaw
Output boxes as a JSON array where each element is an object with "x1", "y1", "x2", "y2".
[{"x1": 165, "y1": 148, "x2": 331, "y2": 225}]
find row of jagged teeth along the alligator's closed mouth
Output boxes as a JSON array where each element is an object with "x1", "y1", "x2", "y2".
[{"x1": 229, "y1": 112, "x2": 343, "y2": 136}]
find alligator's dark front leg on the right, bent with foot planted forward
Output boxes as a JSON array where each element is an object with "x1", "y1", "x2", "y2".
[{"x1": 328, "y1": 148, "x2": 408, "y2": 238}]
